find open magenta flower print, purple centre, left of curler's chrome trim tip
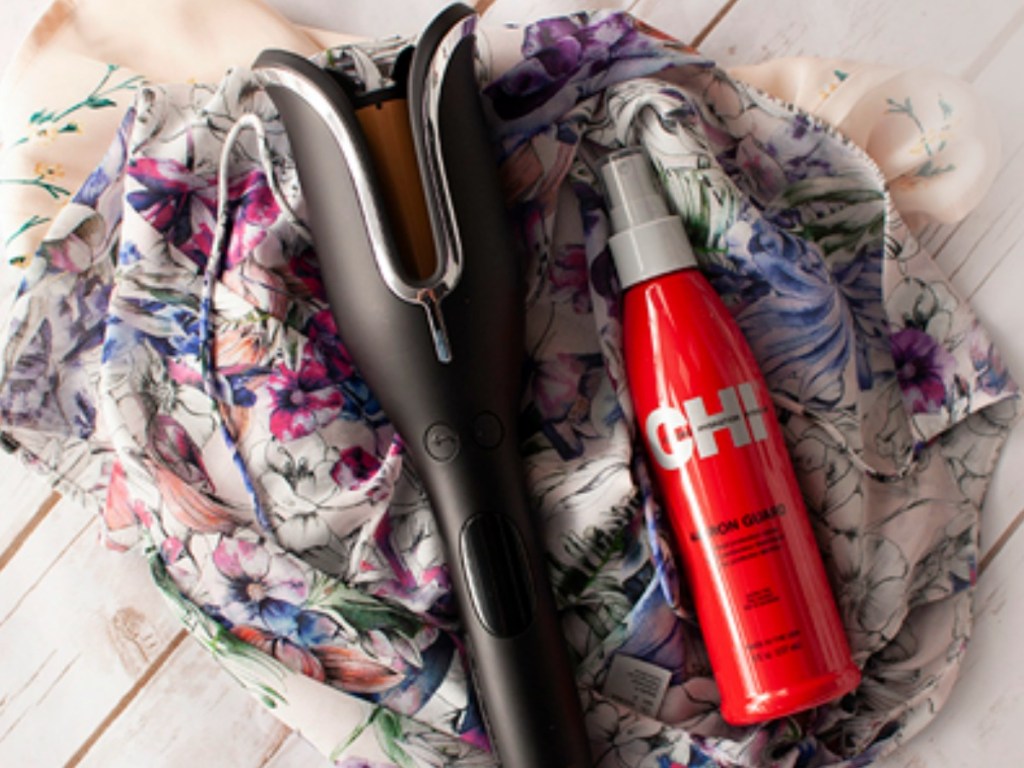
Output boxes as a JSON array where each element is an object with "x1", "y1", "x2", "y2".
[{"x1": 267, "y1": 347, "x2": 345, "y2": 441}]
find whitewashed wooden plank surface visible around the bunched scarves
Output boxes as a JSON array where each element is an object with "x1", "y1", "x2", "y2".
[{"x1": 0, "y1": 0, "x2": 1024, "y2": 768}]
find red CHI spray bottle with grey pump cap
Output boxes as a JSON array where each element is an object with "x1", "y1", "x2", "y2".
[{"x1": 601, "y1": 148, "x2": 860, "y2": 725}]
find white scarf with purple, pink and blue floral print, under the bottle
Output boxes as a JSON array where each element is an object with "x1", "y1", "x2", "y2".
[{"x1": 0, "y1": 14, "x2": 1017, "y2": 768}]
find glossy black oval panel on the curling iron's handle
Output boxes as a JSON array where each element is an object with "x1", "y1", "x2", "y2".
[{"x1": 460, "y1": 513, "x2": 535, "y2": 637}]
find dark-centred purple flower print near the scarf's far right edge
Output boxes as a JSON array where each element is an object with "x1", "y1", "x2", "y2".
[{"x1": 889, "y1": 328, "x2": 956, "y2": 414}]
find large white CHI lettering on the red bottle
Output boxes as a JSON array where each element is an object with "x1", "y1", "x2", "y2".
[{"x1": 644, "y1": 381, "x2": 768, "y2": 469}]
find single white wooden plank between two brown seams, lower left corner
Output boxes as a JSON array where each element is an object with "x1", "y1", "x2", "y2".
[{"x1": 0, "y1": 500, "x2": 181, "y2": 766}]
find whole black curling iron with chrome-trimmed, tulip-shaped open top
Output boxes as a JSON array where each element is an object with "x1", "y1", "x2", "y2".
[{"x1": 254, "y1": 4, "x2": 591, "y2": 768}]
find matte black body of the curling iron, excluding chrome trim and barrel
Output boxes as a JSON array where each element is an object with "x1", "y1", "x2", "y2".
[{"x1": 255, "y1": 6, "x2": 591, "y2": 768}]
